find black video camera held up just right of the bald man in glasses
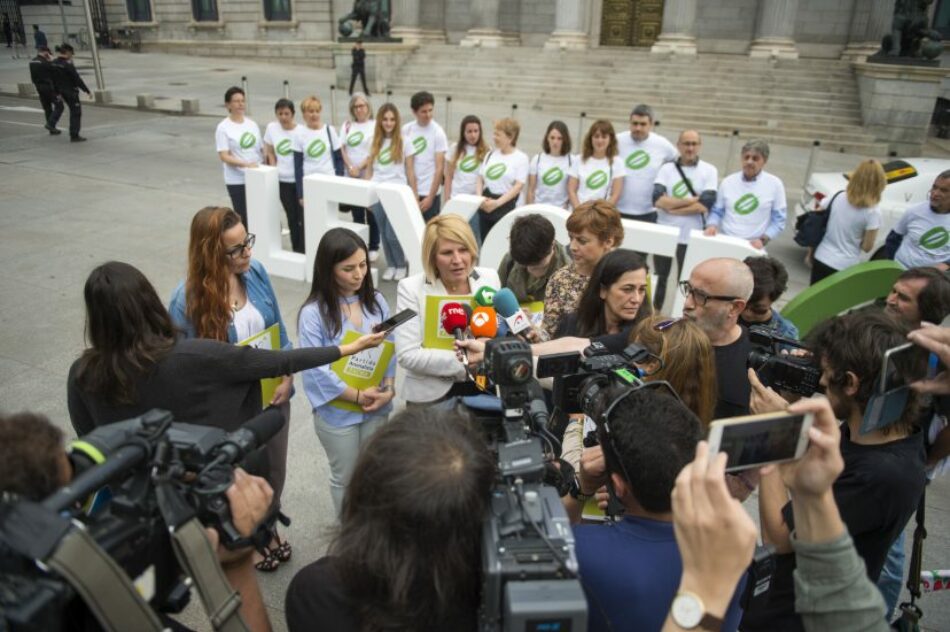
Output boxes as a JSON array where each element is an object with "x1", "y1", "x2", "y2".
[{"x1": 748, "y1": 325, "x2": 821, "y2": 397}]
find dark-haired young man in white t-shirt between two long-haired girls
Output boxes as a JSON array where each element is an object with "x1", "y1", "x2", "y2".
[{"x1": 402, "y1": 92, "x2": 449, "y2": 222}]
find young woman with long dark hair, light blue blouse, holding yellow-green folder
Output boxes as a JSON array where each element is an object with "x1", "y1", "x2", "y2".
[{"x1": 298, "y1": 228, "x2": 396, "y2": 516}]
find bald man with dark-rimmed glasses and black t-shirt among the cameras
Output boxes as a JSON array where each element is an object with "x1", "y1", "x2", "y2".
[{"x1": 680, "y1": 258, "x2": 755, "y2": 419}]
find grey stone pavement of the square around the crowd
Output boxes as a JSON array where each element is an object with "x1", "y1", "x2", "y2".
[{"x1": 0, "y1": 51, "x2": 950, "y2": 631}]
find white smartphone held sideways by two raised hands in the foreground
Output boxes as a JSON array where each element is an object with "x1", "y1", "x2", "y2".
[{"x1": 709, "y1": 412, "x2": 814, "y2": 472}]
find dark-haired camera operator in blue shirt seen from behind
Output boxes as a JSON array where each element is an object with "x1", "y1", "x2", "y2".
[{"x1": 569, "y1": 386, "x2": 740, "y2": 632}]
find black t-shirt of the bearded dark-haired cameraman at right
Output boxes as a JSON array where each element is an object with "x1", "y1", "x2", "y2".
[{"x1": 741, "y1": 424, "x2": 927, "y2": 632}]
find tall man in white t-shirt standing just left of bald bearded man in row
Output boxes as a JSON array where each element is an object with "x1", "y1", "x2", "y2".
[{"x1": 617, "y1": 104, "x2": 677, "y2": 223}]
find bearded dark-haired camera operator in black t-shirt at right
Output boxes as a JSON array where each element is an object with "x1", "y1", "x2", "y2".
[{"x1": 742, "y1": 313, "x2": 926, "y2": 632}]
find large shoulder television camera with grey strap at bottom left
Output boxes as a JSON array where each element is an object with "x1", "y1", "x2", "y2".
[{"x1": 0, "y1": 409, "x2": 284, "y2": 631}]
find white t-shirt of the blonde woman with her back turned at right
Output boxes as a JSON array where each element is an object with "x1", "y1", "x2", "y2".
[{"x1": 815, "y1": 191, "x2": 881, "y2": 270}]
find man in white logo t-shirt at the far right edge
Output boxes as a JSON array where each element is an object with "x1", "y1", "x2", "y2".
[{"x1": 884, "y1": 170, "x2": 950, "y2": 270}]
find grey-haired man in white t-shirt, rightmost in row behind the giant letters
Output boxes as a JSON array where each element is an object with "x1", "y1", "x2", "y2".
[{"x1": 706, "y1": 140, "x2": 788, "y2": 248}]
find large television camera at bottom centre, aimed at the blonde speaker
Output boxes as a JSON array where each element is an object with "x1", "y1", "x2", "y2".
[{"x1": 477, "y1": 338, "x2": 587, "y2": 632}]
